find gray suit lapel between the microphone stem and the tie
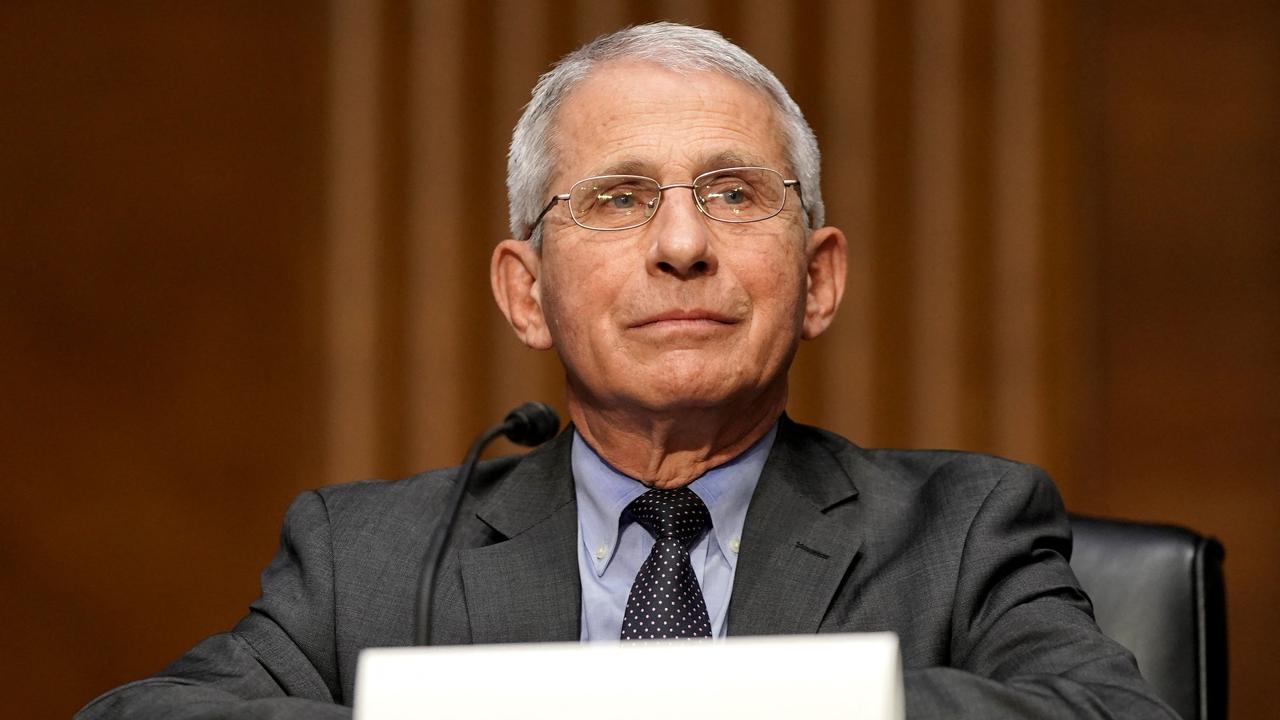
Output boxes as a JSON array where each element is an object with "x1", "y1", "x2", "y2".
[{"x1": 460, "y1": 430, "x2": 581, "y2": 643}]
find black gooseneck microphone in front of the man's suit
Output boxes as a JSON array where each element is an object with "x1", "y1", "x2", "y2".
[{"x1": 413, "y1": 402, "x2": 559, "y2": 646}]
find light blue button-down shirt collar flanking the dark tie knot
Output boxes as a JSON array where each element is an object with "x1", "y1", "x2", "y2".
[{"x1": 571, "y1": 424, "x2": 778, "y2": 575}]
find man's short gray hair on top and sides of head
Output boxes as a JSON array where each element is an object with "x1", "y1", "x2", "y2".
[{"x1": 507, "y1": 22, "x2": 824, "y2": 247}]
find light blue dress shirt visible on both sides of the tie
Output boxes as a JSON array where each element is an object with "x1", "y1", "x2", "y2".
[{"x1": 572, "y1": 425, "x2": 777, "y2": 641}]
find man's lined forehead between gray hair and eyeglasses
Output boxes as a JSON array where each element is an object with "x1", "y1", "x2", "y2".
[{"x1": 549, "y1": 60, "x2": 792, "y2": 192}]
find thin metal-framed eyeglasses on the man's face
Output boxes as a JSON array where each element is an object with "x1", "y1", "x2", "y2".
[{"x1": 525, "y1": 168, "x2": 804, "y2": 240}]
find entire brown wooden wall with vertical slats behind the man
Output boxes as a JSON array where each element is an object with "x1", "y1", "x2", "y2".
[{"x1": 0, "y1": 0, "x2": 1280, "y2": 717}]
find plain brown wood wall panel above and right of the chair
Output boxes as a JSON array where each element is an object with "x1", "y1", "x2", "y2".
[{"x1": 1078, "y1": 1, "x2": 1280, "y2": 719}]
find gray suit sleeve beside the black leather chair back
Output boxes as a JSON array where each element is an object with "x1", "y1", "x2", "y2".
[{"x1": 905, "y1": 465, "x2": 1178, "y2": 720}]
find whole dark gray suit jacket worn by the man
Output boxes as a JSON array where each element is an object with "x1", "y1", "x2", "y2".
[{"x1": 78, "y1": 418, "x2": 1175, "y2": 719}]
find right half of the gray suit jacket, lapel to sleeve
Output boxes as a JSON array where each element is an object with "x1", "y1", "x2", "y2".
[{"x1": 728, "y1": 418, "x2": 1174, "y2": 717}]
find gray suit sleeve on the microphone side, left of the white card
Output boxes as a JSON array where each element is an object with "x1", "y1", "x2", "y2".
[{"x1": 77, "y1": 492, "x2": 351, "y2": 720}]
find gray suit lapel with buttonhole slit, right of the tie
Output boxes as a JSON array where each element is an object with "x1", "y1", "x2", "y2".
[{"x1": 728, "y1": 416, "x2": 861, "y2": 635}]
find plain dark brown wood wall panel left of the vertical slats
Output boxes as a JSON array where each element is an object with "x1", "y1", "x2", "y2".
[{"x1": 0, "y1": 1, "x2": 330, "y2": 717}]
